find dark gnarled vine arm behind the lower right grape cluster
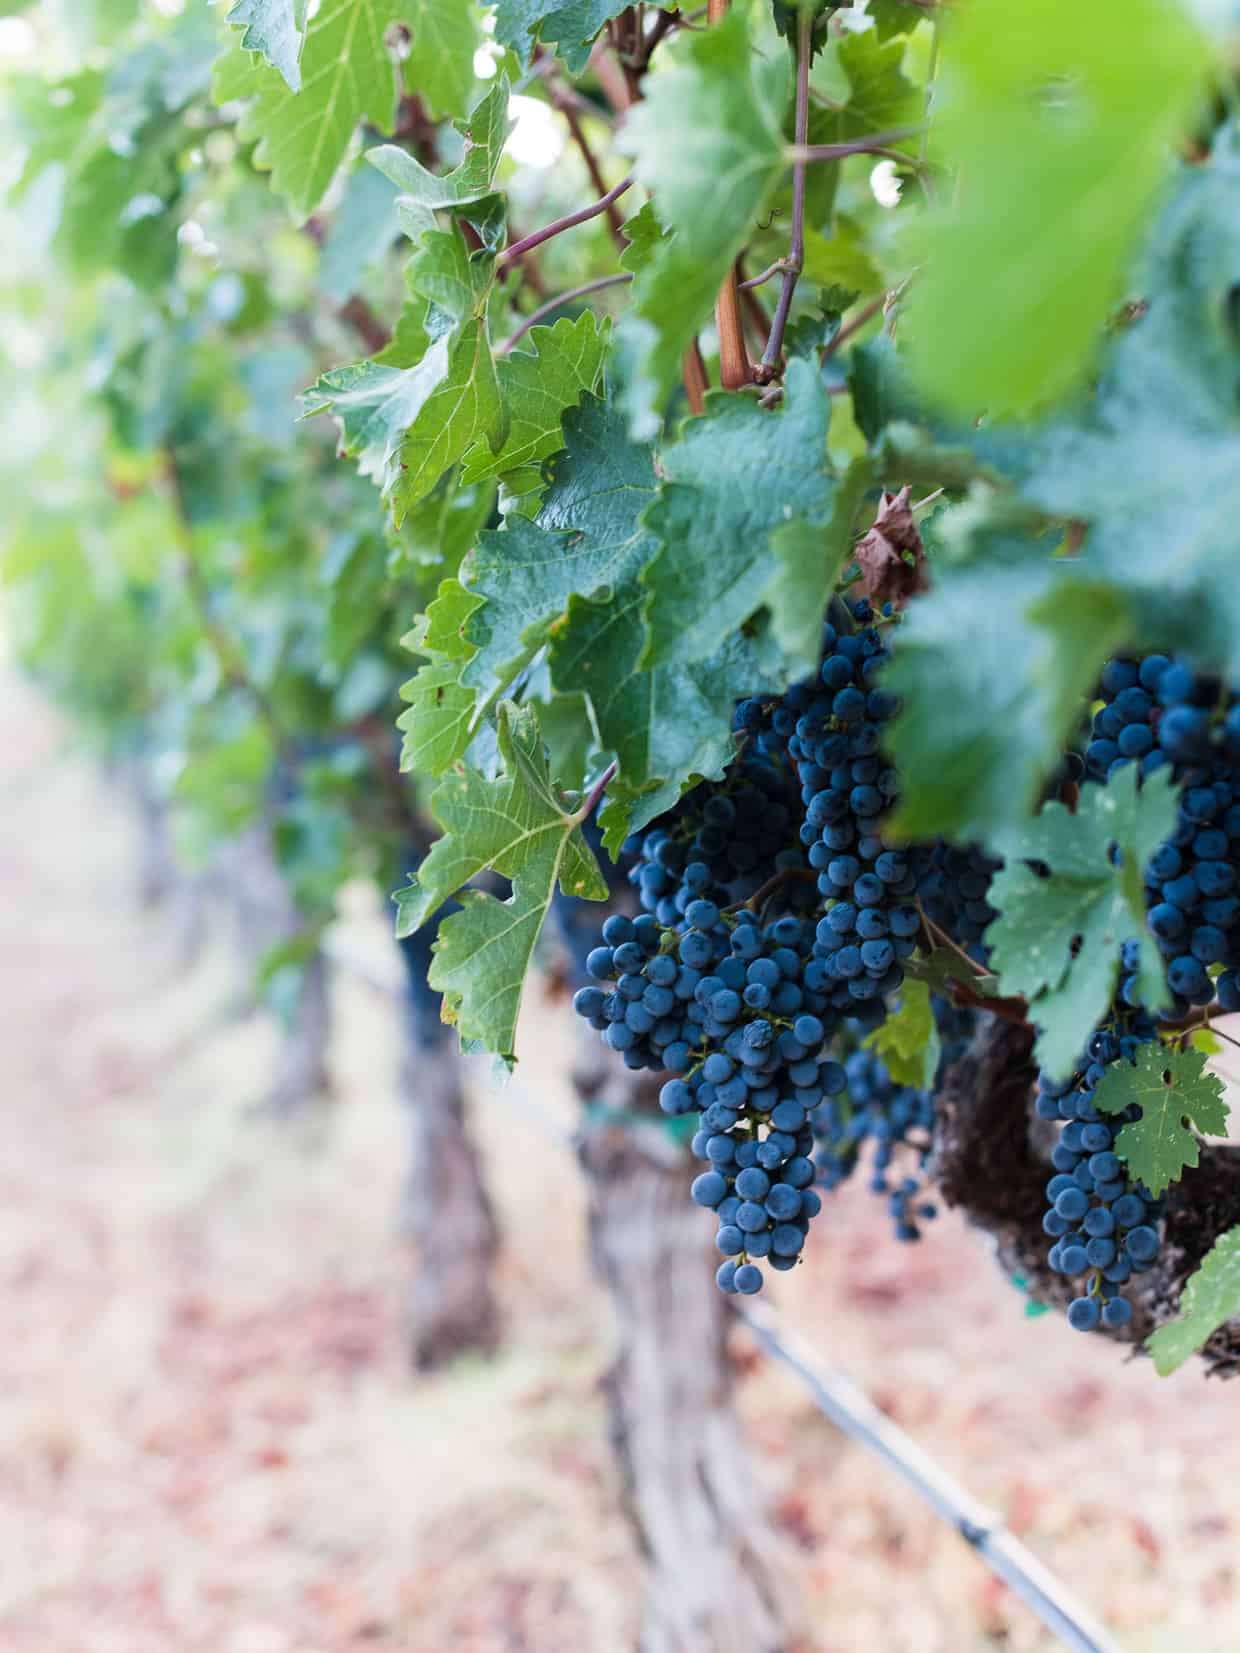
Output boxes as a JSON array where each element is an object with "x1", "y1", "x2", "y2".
[{"x1": 932, "y1": 1017, "x2": 1240, "y2": 1377}]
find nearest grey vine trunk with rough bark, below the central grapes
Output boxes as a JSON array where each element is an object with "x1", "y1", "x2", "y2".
[{"x1": 577, "y1": 1036, "x2": 795, "y2": 1653}]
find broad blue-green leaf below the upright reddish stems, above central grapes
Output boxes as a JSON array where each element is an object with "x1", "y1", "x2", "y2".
[{"x1": 645, "y1": 360, "x2": 837, "y2": 665}]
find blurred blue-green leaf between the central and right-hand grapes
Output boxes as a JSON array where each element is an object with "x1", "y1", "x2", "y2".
[{"x1": 883, "y1": 529, "x2": 1128, "y2": 853}]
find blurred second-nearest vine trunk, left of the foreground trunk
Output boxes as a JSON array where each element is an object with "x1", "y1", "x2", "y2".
[{"x1": 402, "y1": 929, "x2": 499, "y2": 1372}]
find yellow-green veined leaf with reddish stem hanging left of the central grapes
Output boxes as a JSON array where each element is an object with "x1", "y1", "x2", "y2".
[{"x1": 395, "y1": 701, "x2": 607, "y2": 1063}]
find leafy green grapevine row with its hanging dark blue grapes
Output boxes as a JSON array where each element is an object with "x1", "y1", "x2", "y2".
[{"x1": 3, "y1": 0, "x2": 1240, "y2": 1395}]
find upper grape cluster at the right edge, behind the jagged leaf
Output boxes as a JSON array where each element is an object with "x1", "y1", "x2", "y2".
[{"x1": 1085, "y1": 655, "x2": 1240, "y2": 1015}]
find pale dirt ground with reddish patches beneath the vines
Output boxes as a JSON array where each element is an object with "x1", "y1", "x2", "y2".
[{"x1": 0, "y1": 683, "x2": 1240, "y2": 1653}]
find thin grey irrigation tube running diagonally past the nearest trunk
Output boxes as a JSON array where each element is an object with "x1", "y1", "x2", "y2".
[{"x1": 329, "y1": 950, "x2": 1123, "y2": 1653}]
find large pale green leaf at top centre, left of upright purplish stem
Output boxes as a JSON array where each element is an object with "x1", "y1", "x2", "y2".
[{"x1": 622, "y1": 7, "x2": 789, "y2": 436}]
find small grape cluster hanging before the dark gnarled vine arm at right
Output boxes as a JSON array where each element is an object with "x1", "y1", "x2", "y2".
[{"x1": 1037, "y1": 1012, "x2": 1161, "y2": 1331}]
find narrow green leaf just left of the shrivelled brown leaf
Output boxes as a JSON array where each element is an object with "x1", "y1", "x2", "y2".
[{"x1": 765, "y1": 458, "x2": 873, "y2": 678}]
